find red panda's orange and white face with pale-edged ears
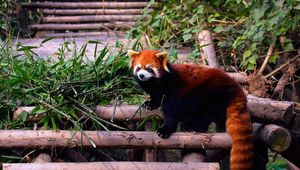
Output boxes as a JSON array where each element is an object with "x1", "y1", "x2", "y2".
[{"x1": 128, "y1": 50, "x2": 170, "y2": 81}]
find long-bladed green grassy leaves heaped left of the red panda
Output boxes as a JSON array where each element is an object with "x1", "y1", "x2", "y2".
[{"x1": 0, "y1": 39, "x2": 143, "y2": 130}]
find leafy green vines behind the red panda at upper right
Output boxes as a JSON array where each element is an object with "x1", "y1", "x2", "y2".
[{"x1": 130, "y1": 0, "x2": 300, "y2": 70}]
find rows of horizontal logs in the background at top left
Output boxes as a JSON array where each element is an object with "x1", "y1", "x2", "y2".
[{"x1": 18, "y1": 0, "x2": 156, "y2": 37}]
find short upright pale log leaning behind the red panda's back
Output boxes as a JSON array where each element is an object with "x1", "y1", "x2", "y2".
[{"x1": 198, "y1": 30, "x2": 220, "y2": 68}]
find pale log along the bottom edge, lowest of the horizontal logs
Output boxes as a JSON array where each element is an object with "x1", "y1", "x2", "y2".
[{"x1": 3, "y1": 162, "x2": 220, "y2": 170}]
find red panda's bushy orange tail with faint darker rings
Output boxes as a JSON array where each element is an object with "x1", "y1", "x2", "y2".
[{"x1": 226, "y1": 94, "x2": 254, "y2": 170}]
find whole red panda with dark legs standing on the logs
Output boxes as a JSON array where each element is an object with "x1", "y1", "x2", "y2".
[{"x1": 128, "y1": 50, "x2": 254, "y2": 170}]
